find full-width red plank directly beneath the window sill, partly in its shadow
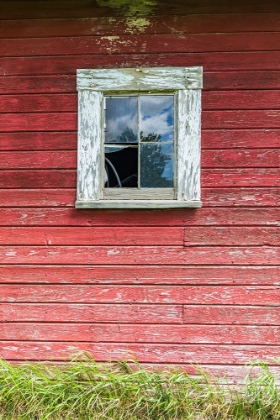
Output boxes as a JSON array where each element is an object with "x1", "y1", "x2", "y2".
[{"x1": 0, "y1": 207, "x2": 280, "y2": 227}]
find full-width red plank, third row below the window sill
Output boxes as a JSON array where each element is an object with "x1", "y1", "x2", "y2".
[{"x1": 0, "y1": 245, "x2": 279, "y2": 265}]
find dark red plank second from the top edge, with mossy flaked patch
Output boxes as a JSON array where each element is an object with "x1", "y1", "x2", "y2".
[{"x1": 0, "y1": 13, "x2": 280, "y2": 39}]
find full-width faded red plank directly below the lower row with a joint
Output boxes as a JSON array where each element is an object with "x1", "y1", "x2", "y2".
[{"x1": 0, "y1": 323, "x2": 280, "y2": 345}]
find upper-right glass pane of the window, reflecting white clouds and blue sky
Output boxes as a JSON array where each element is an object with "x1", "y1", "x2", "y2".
[{"x1": 140, "y1": 95, "x2": 174, "y2": 143}]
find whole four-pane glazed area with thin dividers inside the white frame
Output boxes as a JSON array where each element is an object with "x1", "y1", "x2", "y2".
[{"x1": 104, "y1": 94, "x2": 174, "y2": 189}]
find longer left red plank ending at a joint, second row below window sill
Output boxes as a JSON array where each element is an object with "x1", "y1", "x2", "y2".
[{"x1": 0, "y1": 227, "x2": 184, "y2": 246}]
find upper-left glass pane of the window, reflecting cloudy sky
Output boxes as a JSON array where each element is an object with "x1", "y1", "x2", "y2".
[{"x1": 105, "y1": 96, "x2": 138, "y2": 143}]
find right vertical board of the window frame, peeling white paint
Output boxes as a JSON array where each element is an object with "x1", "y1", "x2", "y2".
[{"x1": 177, "y1": 90, "x2": 201, "y2": 201}]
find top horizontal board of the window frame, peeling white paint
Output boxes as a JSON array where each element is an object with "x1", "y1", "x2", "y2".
[{"x1": 77, "y1": 67, "x2": 202, "y2": 92}]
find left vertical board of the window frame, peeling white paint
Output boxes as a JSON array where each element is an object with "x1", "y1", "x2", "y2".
[{"x1": 77, "y1": 91, "x2": 102, "y2": 200}]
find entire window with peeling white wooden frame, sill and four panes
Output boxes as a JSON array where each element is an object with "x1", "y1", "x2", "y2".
[{"x1": 76, "y1": 67, "x2": 202, "y2": 209}]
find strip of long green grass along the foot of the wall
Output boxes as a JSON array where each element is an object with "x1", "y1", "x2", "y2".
[{"x1": 0, "y1": 356, "x2": 280, "y2": 420}]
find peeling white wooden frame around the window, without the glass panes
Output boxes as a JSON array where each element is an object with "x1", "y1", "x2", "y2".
[{"x1": 75, "y1": 67, "x2": 202, "y2": 209}]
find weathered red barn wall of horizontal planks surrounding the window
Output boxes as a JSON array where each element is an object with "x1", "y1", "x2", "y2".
[{"x1": 0, "y1": 0, "x2": 280, "y2": 376}]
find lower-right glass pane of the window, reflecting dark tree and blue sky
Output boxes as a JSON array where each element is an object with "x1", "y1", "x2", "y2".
[{"x1": 140, "y1": 143, "x2": 174, "y2": 188}]
